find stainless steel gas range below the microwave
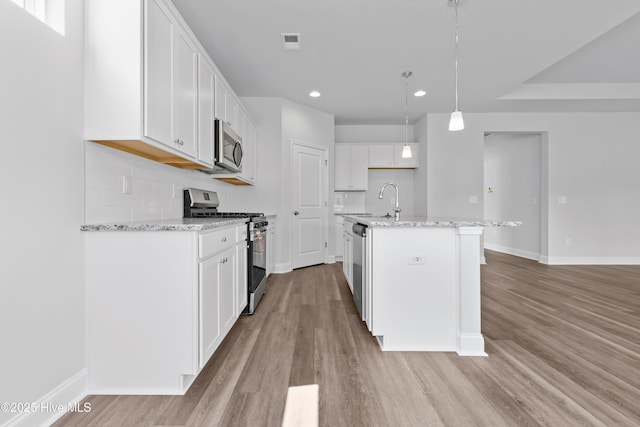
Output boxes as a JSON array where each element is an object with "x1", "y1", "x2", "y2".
[{"x1": 183, "y1": 188, "x2": 269, "y2": 314}]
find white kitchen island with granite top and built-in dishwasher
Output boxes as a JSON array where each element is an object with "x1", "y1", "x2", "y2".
[{"x1": 345, "y1": 216, "x2": 521, "y2": 356}]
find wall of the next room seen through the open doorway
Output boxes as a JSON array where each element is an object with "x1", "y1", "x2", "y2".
[{"x1": 484, "y1": 132, "x2": 542, "y2": 261}]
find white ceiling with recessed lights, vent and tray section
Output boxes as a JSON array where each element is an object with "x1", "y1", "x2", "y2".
[{"x1": 173, "y1": 0, "x2": 640, "y2": 124}]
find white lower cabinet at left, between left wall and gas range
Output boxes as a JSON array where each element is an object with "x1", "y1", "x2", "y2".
[{"x1": 86, "y1": 223, "x2": 247, "y2": 395}]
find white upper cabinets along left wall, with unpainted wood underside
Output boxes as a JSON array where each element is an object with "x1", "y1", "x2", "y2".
[{"x1": 84, "y1": 0, "x2": 252, "y2": 175}]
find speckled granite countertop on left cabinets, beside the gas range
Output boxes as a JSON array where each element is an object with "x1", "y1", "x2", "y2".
[{"x1": 80, "y1": 218, "x2": 249, "y2": 231}]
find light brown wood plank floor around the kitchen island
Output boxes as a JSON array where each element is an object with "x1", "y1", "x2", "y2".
[{"x1": 55, "y1": 251, "x2": 640, "y2": 426}]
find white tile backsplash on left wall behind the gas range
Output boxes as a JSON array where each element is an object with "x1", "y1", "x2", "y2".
[{"x1": 85, "y1": 141, "x2": 226, "y2": 224}]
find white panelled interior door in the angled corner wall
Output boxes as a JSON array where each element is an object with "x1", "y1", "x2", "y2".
[{"x1": 291, "y1": 142, "x2": 328, "y2": 268}]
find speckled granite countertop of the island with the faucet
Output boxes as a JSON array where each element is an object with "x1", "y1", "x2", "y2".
[{"x1": 345, "y1": 215, "x2": 522, "y2": 227}]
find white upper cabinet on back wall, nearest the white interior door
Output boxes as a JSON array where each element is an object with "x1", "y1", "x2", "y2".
[{"x1": 335, "y1": 144, "x2": 369, "y2": 191}]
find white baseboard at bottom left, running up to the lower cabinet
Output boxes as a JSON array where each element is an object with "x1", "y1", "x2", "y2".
[{"x1": 5, "y1": 369, "x2": 91, "y2": 427}]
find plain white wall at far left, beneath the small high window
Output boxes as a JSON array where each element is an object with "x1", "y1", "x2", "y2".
[{"x1": 0, "y1": 0, "x2": 86, "y2": 425}]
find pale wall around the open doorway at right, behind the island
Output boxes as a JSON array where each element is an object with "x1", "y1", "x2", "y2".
[{"x1": 427, "y1": 113, "x2": 640, "y2": 264}]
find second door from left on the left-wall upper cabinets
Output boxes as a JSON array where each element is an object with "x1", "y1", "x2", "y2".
[{"x1": 172, "y1": 24, "x2": 198, "y2": 157}]
